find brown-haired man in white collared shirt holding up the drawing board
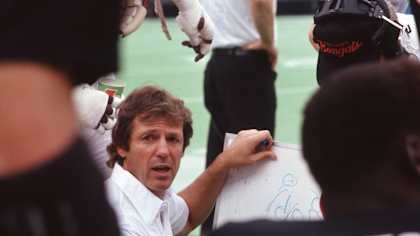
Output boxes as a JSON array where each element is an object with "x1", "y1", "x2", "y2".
[{"x1": 106, "y1": 86, "x2": 275, "y2": 236}]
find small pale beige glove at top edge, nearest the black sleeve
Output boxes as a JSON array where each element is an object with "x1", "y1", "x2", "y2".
[{"x1": 120, "y1": 0, "x2": 147, "y2": 37}]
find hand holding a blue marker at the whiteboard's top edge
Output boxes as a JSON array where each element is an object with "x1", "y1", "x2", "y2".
[{"x1": 218, "y1": 129, "x2": 276, "y2": 169}]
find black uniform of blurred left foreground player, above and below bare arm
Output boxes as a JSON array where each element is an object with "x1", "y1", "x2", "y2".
[{"x1": 0, "y1": 0, "x2": 120, "y2": 236}]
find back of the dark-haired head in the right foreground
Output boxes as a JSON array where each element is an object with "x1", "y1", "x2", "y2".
[{"x1": 302, "y1": 59, "x2": 420, "y2": 194}]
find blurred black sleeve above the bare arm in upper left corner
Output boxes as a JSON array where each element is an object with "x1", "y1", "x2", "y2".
[{"x1": 0, "y1": 0, "x2": 120, "y2": 84}]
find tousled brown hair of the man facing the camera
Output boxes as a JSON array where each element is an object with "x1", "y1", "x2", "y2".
[{"x1": 107, "y1": 86, "x2": 193, "y2": 168}]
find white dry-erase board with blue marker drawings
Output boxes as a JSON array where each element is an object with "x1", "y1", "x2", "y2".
[{"x1": 213, "y1": 134, "x2": 321, "y2": 228}]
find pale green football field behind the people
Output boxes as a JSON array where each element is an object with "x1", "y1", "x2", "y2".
[{"x1": 119, "y1": 16, "x2": 317, "y2": 235}]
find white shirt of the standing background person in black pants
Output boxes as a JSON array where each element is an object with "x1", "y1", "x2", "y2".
[{"x1": 201, "y1": 0, "x2": 277, "y2": 48}]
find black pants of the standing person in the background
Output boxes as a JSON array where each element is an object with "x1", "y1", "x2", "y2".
[{"x1": 202, "y1": 48, "x2": 277, "y2": 231}]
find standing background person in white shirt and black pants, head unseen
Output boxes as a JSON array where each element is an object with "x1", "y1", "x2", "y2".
[{"x1": 202, "y1": 0, "x2": 277, "y2": 231}]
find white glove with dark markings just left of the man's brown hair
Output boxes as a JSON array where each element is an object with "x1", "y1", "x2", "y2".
[{"x1": 73, "y1": 84, "x2": 121, "y2": 132}]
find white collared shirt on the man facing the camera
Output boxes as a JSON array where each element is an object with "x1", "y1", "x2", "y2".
[{"x1": 106, "y1": 164, "x2": 189, "y2": 236}]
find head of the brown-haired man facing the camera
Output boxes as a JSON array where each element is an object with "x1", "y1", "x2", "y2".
[{"x1": 108, "y1": 86, "x2": 192, "y2": 197}]
